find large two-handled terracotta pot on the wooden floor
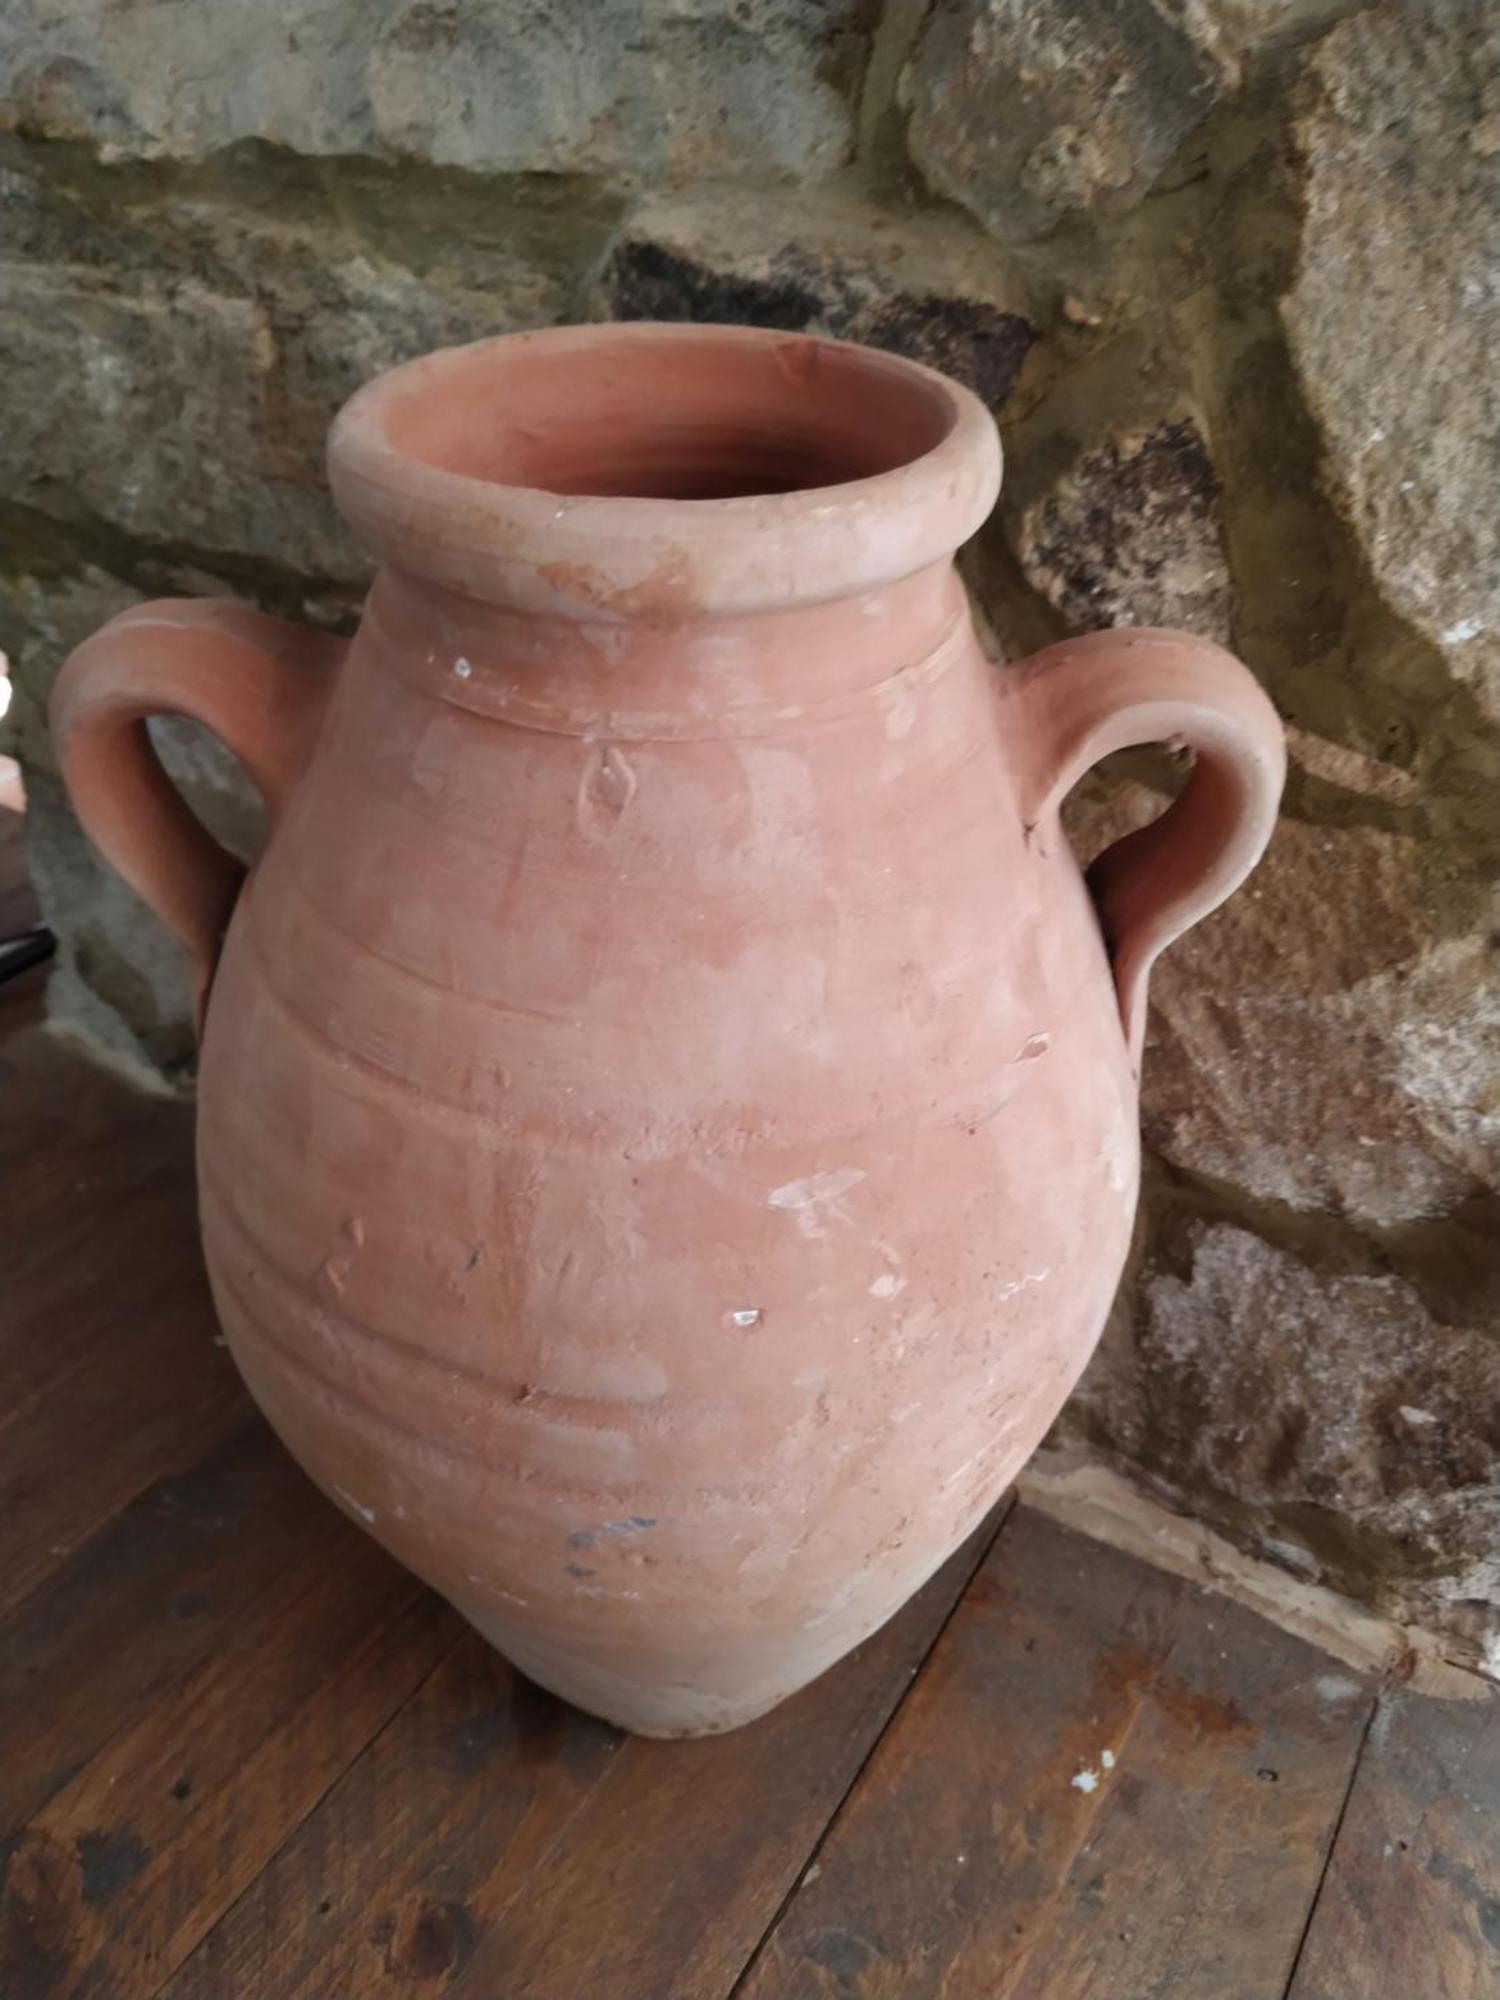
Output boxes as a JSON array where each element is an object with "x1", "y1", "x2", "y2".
[{"x1": 52, "y1": 326, "x2": 1282, "y2": 1736}]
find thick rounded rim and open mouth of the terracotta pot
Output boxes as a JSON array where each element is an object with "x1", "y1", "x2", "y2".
[{"x1": 328, "y1": 322, "x2": 1000, "y2": 624}]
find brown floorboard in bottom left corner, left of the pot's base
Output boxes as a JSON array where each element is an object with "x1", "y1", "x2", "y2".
[{"x1": 0, "y1": 1508, "x2": 460, "y2": 2000}]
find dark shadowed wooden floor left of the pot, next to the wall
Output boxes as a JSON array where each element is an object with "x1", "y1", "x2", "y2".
[{"x1": 0, "y1": 990, "x2": 229, "y2": 1610}]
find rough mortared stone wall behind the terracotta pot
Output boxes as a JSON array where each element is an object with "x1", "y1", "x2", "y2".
[{"x1": 0, "y1": 0, "x2": 1500, "y2": 1672}]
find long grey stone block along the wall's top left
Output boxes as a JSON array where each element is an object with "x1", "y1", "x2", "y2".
[{"x1": 0, "y1": 0, "x2": 868, "y2": 180}]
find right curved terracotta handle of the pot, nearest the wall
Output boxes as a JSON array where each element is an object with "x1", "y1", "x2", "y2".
[{"x1": 1012, "y1": 626, "x2": 1286, "y2": 1068}]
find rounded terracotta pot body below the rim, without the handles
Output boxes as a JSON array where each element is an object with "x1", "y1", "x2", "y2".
[{"x1": 200, "y1": 566, "x2": 1136, "y2": 1732}]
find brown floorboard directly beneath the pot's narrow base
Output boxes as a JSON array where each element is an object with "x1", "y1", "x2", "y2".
[{"x1": 164, "y1": 1512, "x2": 1004, "y2": 2000}]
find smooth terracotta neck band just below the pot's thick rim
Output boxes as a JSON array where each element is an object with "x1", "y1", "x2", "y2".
[{"x1": 366, "y1": 560, "x2": 972, "y2": 740}]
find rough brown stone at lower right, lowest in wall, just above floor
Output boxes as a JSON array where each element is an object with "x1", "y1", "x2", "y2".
[{"x1": 1064, "y1": 1222, "x2": 1500, "y2": 1672}]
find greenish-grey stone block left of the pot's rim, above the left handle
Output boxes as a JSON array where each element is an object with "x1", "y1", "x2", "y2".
[{"x1": 0, "y1": 144, "x2": 618, "y2": 584}]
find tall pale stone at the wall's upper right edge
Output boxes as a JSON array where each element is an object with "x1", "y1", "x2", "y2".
[{"x1": 1284, "y1": 0, "x2": 1500, "y2": 720}]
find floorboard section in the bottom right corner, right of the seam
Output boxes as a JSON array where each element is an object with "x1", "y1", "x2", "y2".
[{"x1": 1290, "y1": 1692, "x2": 1500, "y2": 2000}]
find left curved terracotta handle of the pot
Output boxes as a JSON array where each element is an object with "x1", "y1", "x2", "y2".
[{"x1": 50, "y1": 598, "x2": 348, "y2": 1030}]
